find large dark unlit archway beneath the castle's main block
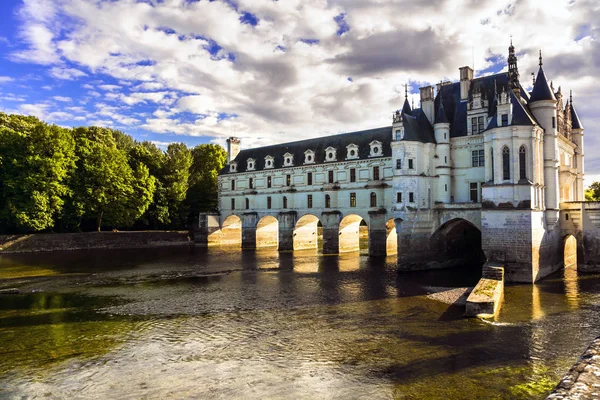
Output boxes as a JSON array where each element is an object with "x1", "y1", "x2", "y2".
[{"x1": 430, "y1": 218, "x2": 485, "y2": 269}]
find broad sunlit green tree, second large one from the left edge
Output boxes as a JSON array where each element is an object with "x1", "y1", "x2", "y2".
[{"x1": 72, "y1": 127, "x2": 155, "y2": 231}]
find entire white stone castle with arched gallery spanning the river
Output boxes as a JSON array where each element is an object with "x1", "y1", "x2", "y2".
[{"x1": 200, "y1": 43, "x2": 584, "y2": 282}]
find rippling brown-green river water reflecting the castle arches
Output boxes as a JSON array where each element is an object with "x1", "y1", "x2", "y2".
[{"x1": 0, "y1": 247, "x2": 600, "y2": 399}]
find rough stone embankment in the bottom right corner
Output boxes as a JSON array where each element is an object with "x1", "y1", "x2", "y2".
[{"x1": 546, "y1": 337, "x2": 600, "y2": 400}]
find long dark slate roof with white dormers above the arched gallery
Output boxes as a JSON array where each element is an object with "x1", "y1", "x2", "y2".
[{"x1": 220, "y1": 126, "x2": 392, "y2": 175}]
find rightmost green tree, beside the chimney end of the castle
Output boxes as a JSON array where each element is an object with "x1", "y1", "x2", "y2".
[{"x1": 186, "y1": 144, "x2": 227, "y2": 220}]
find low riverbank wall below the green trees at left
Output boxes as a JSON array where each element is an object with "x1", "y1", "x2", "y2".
[{"x1": 0, "y1": 231, "x2": 193, "y2": 254}]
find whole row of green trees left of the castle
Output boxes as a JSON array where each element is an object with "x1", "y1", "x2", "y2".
[{"x1": 0, "y1": 112, "x2": 227, "y2": 233}]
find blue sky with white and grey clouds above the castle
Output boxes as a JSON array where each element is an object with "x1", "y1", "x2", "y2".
[{"x1": 0, "y1": 0, "x2": 600, "y2": 184}]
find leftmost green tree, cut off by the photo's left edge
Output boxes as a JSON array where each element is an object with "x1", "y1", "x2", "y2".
[{"x1": 0, "y1": 113, "x2": 75, "y2": 232}]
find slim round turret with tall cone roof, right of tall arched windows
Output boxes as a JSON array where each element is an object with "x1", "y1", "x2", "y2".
[{"x1": 529, "y1": 51, "x2": 560, "y2": 227}]
